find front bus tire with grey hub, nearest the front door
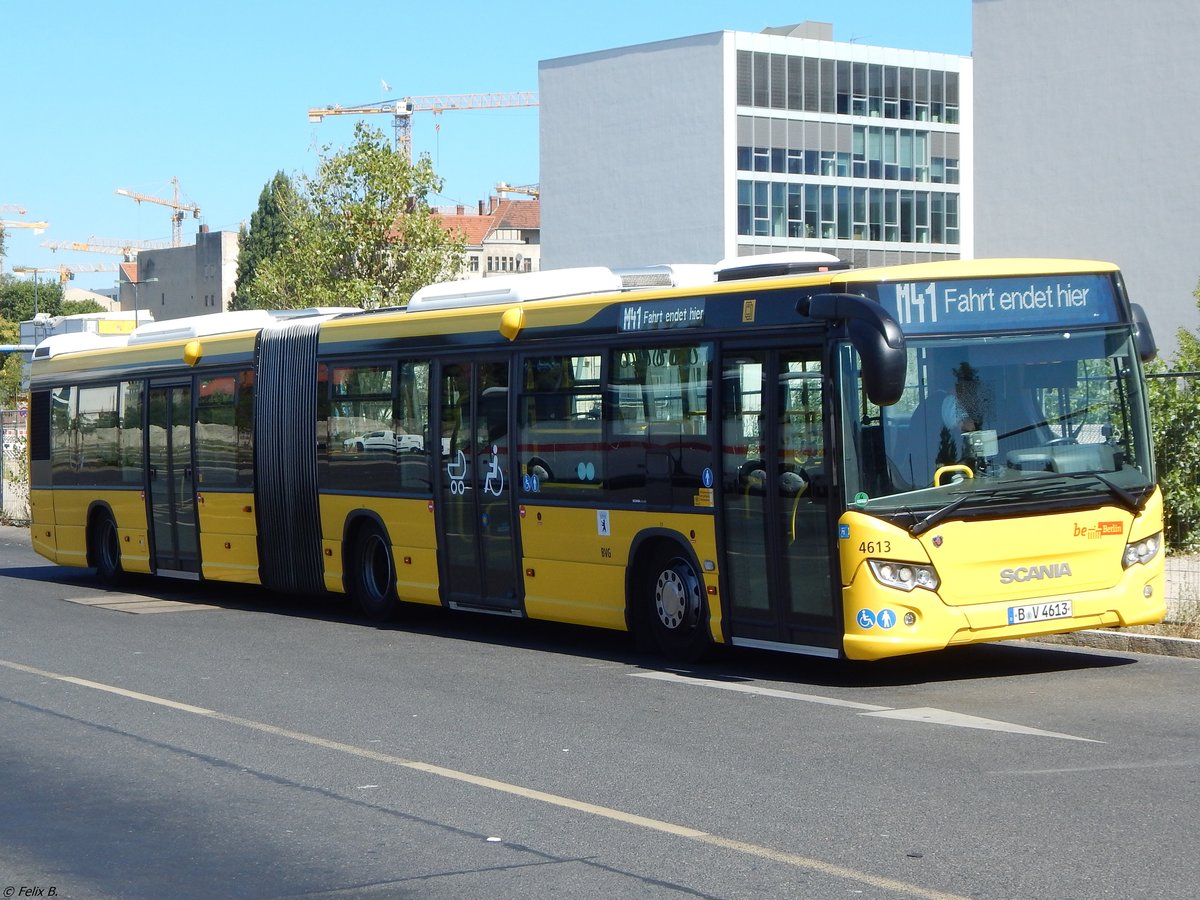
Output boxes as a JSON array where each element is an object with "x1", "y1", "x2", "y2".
[{"x1": 641, "y1": 546, "x2": 713, "y2": 662}]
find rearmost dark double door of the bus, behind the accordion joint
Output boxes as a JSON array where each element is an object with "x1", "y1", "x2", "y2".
[{"x1": 146, "y1": 383, "x2": 200, "y2": 578}]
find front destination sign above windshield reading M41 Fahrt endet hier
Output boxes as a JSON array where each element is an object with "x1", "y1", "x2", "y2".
[{"x1": 878, "y1": 275, "x2": 1121, "y2": 335}]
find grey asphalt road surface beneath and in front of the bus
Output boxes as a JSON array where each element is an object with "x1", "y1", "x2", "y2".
[{"x1": 0, "y1": 528, "x2": 1200, "y2": 899}]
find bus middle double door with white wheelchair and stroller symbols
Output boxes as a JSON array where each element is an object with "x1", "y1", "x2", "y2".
[{"x1": 434, "y1": 359, "x2": 521, "y2": 613}]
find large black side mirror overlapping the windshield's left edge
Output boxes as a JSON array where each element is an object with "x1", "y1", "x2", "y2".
[{"x1": 797, "y1": 294, "x2": 908, "y2": 407}]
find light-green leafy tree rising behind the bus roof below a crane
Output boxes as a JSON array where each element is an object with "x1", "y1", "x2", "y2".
[{"x1": 247, "y1": 122, "x2": 463, "y2": 308}]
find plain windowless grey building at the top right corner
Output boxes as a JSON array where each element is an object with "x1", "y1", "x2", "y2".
[{"x1": 972, "y1": 0, "x2": 1200, "y2": 352}]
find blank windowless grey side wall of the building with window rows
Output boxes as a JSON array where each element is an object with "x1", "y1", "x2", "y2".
[{"x1": 538, "y1": 32, "x2": 734, "y2": 269}]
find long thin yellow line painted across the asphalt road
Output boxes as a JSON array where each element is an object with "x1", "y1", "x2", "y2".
[{"x1": 0, "y1": 660, "x2": 967, "y2": 900}]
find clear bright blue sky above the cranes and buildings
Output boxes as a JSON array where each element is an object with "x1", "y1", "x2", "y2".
[{"x1": 0, "y1": 0, "x2": 971, "y2": 287}]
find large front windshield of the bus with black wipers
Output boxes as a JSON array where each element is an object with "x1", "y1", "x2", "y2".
[{"x1": 840, "y1": 328, "x2": 1154, "y2": 527}]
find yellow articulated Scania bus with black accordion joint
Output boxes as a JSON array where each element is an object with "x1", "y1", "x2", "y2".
[{"x1": 23, "y1": 253, "x2": 1165, "y2": 659}]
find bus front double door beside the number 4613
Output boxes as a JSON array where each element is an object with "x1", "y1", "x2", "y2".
[{"x1": 721, "y1": 346, "x2": 841, "y2": 655}]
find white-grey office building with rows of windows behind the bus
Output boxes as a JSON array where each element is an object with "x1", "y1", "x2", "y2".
[{"x1": 539, "y1": 23, "x2": 972, "y2": 268}]
